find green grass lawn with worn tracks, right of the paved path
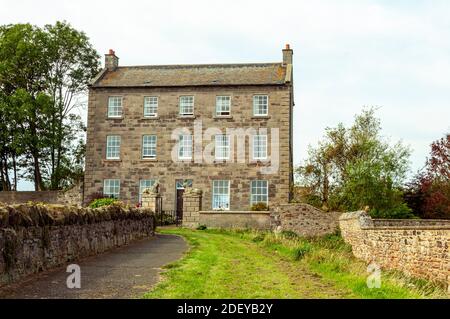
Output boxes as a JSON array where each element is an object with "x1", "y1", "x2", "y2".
[{"x1": 144, "y1": 228, "x2": 445, "y2": 299}]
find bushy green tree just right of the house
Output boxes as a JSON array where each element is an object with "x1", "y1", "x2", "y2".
[{"x1": 297, "y1": 108, "x2": 411, "y2": 218}]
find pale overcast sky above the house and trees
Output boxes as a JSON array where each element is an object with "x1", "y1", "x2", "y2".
[{"x1": 0, "y1": 0, "x2": 450, "y2": 189}]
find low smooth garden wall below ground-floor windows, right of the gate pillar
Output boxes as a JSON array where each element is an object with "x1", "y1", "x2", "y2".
[{"x1": 199, "y1": 211, "x2": 271, "y2": 230}]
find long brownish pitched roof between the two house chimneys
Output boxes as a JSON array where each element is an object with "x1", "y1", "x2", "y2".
[{"x1": 91, "y1": 63, "x2": 292, "y2": 87}]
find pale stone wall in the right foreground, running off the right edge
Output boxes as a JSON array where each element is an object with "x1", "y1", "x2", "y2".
[{"x1": 339, "y1": 212, "x2": 450, "y2": 292}]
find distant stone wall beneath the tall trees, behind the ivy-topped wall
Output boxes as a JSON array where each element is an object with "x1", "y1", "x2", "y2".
[{"x1": 0, "y1": 184, "x2": 83, "y2": 206}]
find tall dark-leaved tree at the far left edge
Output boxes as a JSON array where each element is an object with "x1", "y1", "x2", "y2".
[{"x1": 0, "y1": 24, "x2": 49, "y2": 190}]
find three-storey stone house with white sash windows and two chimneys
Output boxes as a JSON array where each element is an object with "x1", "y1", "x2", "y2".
[{"x1": 84, "y1": 45, "x2": 294, "y2": 219}]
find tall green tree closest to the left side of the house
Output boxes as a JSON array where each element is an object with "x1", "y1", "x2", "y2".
[{"x1": 44, "y1": 22, "x2": 100, "y2": 189}]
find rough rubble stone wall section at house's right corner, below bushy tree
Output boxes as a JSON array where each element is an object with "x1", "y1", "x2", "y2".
[{"x1": 272, "y1": 203, "x2": 341, "y2": 237}]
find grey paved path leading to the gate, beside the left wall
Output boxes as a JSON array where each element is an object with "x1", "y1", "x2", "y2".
[{"x1": 0, "y1": 234, "x2": 188, "y2": 298}]
